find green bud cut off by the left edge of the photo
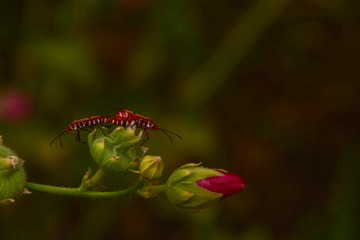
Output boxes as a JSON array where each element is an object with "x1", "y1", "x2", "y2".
[{"x1": 0, "y1": 140, "x2": 25, "y2": 204}]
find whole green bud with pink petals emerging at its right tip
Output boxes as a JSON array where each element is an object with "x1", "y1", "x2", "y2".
[{"x1": 166, "y1": 163, "x2": 245, "y2": 210}]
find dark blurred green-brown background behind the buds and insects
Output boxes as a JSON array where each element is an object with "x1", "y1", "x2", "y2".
[{"x1": 0, "y1": 0, "x2": 360, "y2": 240}]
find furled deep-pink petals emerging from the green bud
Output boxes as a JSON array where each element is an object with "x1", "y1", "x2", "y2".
[{"x1": 196, "y1": 170, "x2": 246, "y2": 198}]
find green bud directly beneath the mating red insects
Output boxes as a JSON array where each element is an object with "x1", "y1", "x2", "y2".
[{"x1": 88, "y1": 127, "x2": 145, "y2": 173}]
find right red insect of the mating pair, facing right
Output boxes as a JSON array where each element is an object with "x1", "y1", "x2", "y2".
[{"x1": 111, "y1": 110, "x2": 182, "y2": 143}]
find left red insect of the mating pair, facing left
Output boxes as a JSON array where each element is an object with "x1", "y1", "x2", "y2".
[{"x1": 50, "y1": 116, "x2": 113, "y2": 147}]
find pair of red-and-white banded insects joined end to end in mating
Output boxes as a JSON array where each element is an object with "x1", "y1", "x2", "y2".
[{"x1": 50, "y1": 110, "x2": 182, "y2": 147}]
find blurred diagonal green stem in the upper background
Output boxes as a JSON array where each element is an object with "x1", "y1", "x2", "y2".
[{"x1": 179, "y1": 0, "x2": 291, "y2": 109}]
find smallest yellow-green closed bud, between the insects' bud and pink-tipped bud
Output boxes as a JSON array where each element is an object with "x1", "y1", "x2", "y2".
[{"x1": 139, "y1": 155, "x2": 164, "y2": 181}]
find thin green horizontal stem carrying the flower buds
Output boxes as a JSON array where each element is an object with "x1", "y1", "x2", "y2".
[{"x1": 25, "y1": 181, "x2": 165, "y2": 199}]
